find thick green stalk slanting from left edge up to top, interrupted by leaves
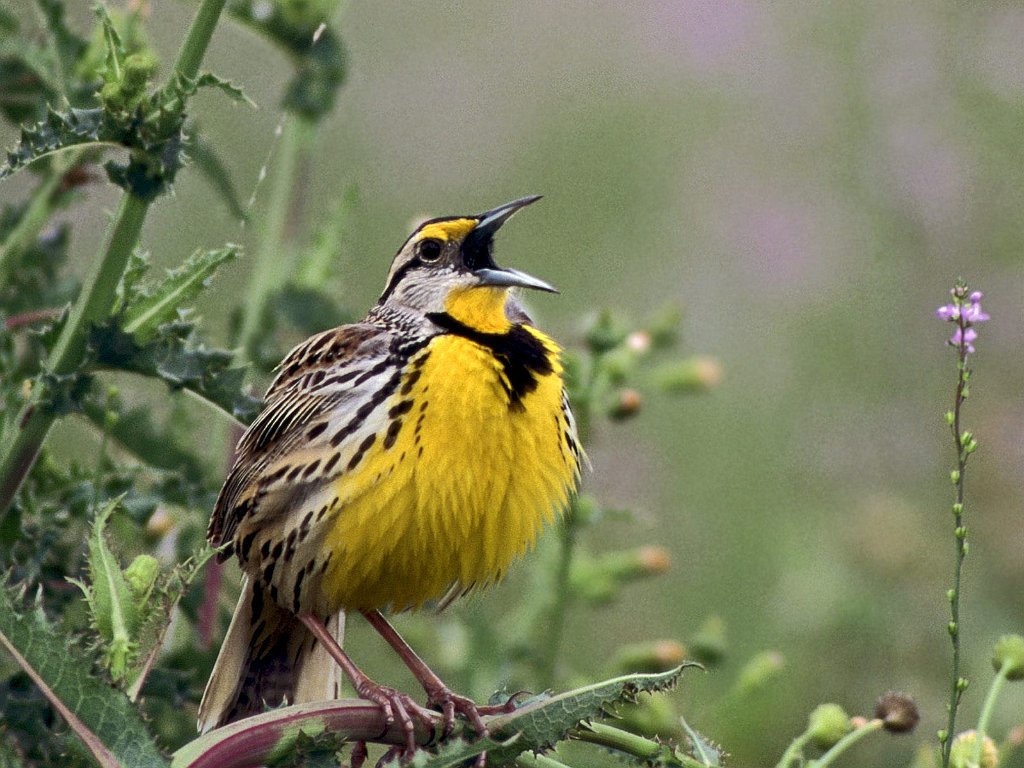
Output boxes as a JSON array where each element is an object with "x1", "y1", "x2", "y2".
[{"x1": 0, "y1": 0, "x2": 225, "y2": 511}]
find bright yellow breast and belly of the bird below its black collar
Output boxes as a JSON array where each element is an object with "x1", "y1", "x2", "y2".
[{"x1": 323, "y1": 327, "x2": 579, "y2": 609}]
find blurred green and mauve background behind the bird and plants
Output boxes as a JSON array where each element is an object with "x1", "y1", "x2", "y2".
[{"x1": 0, "y1": 0, "x2": 1024, "y2": 766}]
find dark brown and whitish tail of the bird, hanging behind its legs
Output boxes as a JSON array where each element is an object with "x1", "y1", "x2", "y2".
[{"x1": 199, "y1": 577, "x2": 345, "y2": 733}]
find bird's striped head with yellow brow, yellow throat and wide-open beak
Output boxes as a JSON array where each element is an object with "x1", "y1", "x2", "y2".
[{"x1": 379, "y1": 196, "x2": 558, "y2": 331}]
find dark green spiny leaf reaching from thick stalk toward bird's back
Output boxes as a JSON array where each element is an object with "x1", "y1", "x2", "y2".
[{"x1": 89, "y1": 321, "x2": 262, "y2": 424}]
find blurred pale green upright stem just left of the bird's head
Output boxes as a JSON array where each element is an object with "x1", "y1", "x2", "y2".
[{"x1": 239, "y1": 115, "x2": 315, "y2": 362}]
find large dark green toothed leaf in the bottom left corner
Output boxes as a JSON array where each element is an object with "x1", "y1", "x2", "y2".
[{"x1": 0, "y1": 583, "x2": 167, "y2": 768}]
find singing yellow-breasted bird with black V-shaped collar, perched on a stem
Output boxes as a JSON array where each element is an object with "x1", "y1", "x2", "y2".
[{"x1": 199, "y1": 197, "x2": 586, "y2": 749}]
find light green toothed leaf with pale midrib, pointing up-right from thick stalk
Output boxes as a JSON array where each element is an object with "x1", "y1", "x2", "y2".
[{"x1": 121, "y1": 245, "x2": 239, "y2": 343}]
